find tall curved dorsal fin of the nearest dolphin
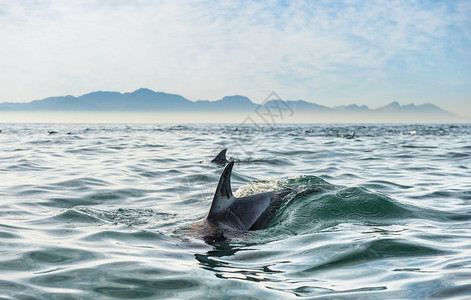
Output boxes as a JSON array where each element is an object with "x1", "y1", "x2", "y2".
[{"x1": 207, "y1": 161, "x2": 235, "y2": 219}]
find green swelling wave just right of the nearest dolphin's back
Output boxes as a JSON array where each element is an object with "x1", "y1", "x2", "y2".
[{"x1": 221, "y1": 176, "x2": 471, "y2": 243}]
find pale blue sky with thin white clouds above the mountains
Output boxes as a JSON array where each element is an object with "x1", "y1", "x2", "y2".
[{"x1": 0, "y1": 0, "x2": 471, "y2": 117}]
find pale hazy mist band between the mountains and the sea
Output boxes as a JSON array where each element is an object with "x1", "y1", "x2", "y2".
[{"x1": 0, "y1": 111, "x2": 471, "y2": 124}]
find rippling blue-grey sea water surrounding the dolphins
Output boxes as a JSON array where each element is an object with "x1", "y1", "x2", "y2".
[{"x1": 0, "y1": 124, "x2": 471, "y2": 299}]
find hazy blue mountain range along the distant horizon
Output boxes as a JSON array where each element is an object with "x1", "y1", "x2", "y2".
[{"x1": 0, "y1": 88, "x2": 458, "y2": 122}]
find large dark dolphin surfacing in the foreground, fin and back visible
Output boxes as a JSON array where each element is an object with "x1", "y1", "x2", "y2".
[{"x1": 201, "y1": 161, "x2": 293, "y2": 241}]
